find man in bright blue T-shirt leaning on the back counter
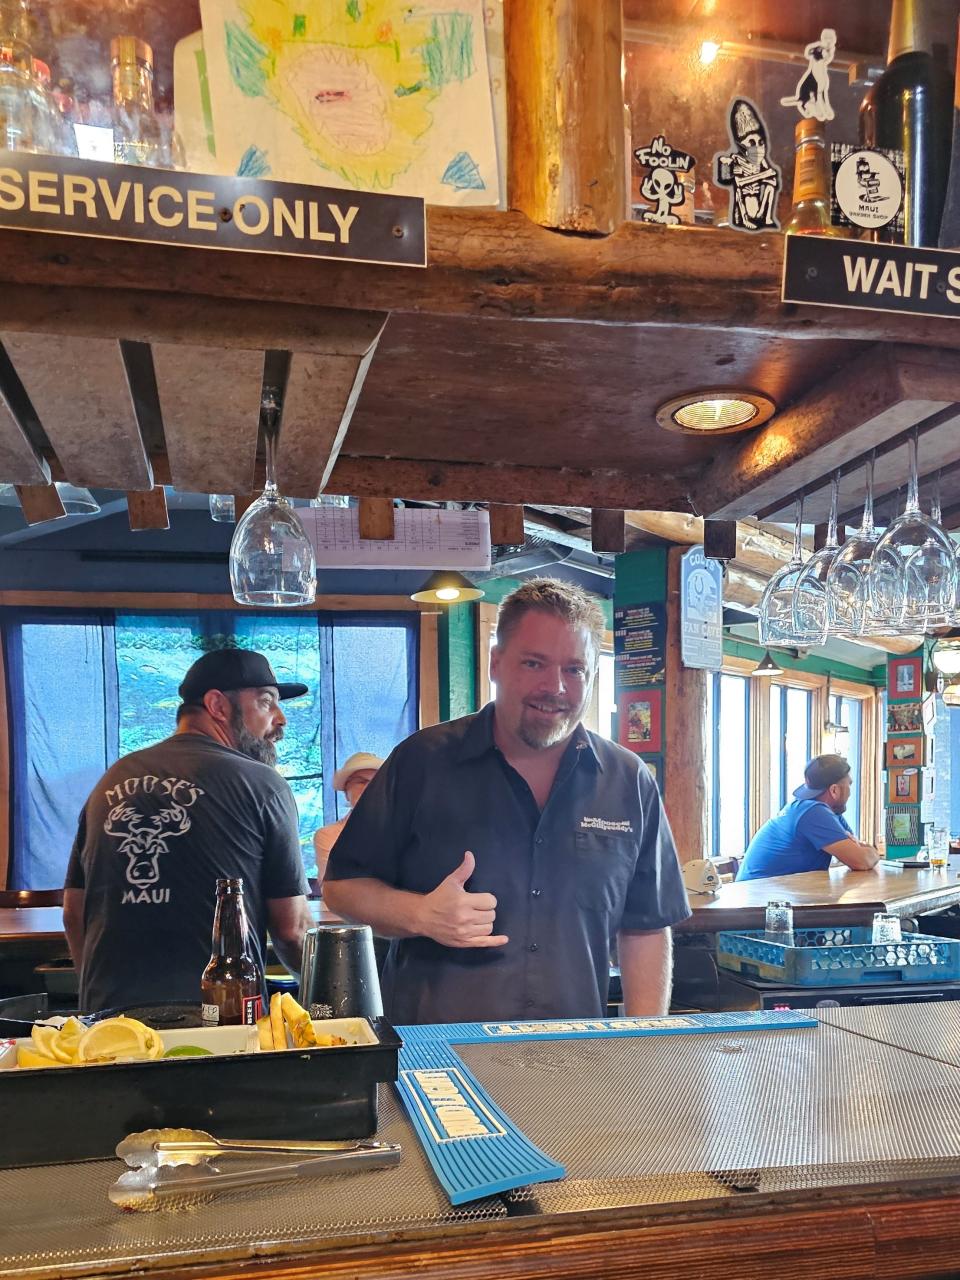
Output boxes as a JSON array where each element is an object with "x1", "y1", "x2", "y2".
[{"x1": 737, "y1": 755, "x2": 879, "y2": 879}]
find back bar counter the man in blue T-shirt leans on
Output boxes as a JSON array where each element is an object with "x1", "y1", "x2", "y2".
[{"x1": 677, "y1": 858, "x2": 960, "y2": 933}]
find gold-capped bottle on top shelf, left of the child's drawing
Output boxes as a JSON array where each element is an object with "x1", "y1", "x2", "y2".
[{"x1": 110, "y1": 36, "x2": 183, "y2": 169}]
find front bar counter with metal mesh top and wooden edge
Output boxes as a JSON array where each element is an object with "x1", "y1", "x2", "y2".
[{"x1": 0, "y1": 1005, "x2": 960, "y2": 1280}]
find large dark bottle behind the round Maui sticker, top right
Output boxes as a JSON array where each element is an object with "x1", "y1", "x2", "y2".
[{"x1": 860, "y1": 0, "x2": 952, "y2": 246}]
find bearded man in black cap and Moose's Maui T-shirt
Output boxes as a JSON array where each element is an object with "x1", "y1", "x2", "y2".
[{"x1": 64, "y1": 649, "x2": 312, "y2": 1012}]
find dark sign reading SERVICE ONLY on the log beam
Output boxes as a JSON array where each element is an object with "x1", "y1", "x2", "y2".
[{"x1": 0, "y1": 151, "x2": 426, "y2": 266}]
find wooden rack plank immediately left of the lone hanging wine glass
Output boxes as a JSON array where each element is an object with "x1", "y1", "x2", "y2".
[{"x1": 154, "y1": 343, "x2": 264, "y2": 493}]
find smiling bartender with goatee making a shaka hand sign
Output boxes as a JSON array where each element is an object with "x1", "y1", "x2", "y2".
[{"x1": 324, "y1": 579, "x2": 690, "y2": 1023}]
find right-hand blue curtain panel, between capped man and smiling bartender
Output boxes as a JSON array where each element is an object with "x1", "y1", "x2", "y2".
[{"x1": 320, "y1": 612, "x2": 420, "y2": 822}]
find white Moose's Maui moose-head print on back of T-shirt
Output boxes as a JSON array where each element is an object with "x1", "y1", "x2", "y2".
[{"x1": 104, "y1": 776, "x2": 204, "y2": 904}]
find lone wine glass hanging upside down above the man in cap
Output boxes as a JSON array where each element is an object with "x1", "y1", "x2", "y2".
[{"x1": 230, "y1": 394, "x2": 316, "y2": 608}]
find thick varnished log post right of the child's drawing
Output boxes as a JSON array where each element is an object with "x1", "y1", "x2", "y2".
[{"x1": 503, "y1": 0, "x2": 626, "y2": 234}]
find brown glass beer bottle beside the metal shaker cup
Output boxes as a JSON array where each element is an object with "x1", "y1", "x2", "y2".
[{"x1": 200, "y1": 879, "x2": 264, "y2": 1027}]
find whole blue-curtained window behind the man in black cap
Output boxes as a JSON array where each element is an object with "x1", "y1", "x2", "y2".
[{"x1": 4, "y1": 611, "x2": 420, "y2": 888}]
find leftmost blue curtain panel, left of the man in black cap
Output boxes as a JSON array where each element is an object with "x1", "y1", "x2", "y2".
[{"x1": 4, "y1": 611, "x2": 118, "y2": 888}]
